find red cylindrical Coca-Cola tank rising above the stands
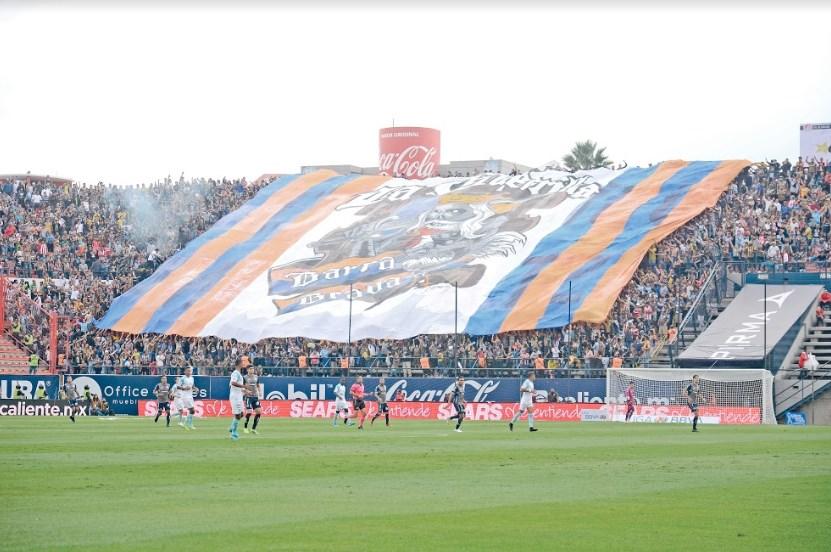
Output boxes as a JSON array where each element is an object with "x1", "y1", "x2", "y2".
[{"x1": 378, "y1": 127, "x2": 441, "y2": 180}]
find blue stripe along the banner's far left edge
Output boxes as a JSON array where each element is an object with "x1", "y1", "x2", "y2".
[{"x1": 96, "y1": 174, "x2": 300, "y2": 328}]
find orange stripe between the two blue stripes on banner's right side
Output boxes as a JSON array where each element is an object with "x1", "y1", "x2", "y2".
[{"x1": 500, "y1": 161, "x2": 687, "y2": 332}]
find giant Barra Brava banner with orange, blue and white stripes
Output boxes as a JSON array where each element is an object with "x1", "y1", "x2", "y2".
[{"x1": 97, "y1": 161, "x2": 748, "y2": 342}]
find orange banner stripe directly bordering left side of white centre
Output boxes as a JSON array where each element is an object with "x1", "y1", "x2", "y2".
[{"x1": 168, "y1": 176, "x2": 390, "y2": 335}]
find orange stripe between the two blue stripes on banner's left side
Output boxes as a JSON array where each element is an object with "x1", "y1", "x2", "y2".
[{"x1": 112, "y1": 170, "x2": 337, "y2": 333}]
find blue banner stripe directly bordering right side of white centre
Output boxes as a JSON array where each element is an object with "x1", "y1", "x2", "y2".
[{"x1": 465, "y1": 165, "x2": 658, "y2": 335}]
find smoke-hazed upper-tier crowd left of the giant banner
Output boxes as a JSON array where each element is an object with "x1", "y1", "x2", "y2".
[{"x1": 0, "y1": 176, "x2": 258, "y2": 283}]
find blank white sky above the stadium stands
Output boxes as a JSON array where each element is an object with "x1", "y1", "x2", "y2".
[{"x1": 0, "y1": 0, "x2": 831, "y2": 185}]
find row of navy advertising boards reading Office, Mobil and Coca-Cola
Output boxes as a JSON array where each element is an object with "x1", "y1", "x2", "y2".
[{"x1": 73, "y1": 374, "x2": 606, "y2": 414}]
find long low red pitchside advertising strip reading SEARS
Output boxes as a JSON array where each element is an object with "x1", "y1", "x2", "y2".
[{"x1": 138, "y1": 400, "x2": 760, "y2": 427}]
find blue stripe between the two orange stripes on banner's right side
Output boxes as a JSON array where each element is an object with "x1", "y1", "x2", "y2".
[{"x1": 537, "y1": 161, "x2": 720, "y2": 328}]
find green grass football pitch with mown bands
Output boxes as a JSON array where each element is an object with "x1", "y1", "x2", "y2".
[{"x1": 0, "y1": 418, "x2": 831, "y2": 551}]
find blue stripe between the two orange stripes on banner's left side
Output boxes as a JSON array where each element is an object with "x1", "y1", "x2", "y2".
[{"x1": 144, "y1": 175, "x2": 358, "y2": 333}]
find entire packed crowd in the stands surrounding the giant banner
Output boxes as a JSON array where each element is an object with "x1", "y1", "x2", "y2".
[{"x1": 0, "y1": 159, "x2": 831, "y2": 375}]
